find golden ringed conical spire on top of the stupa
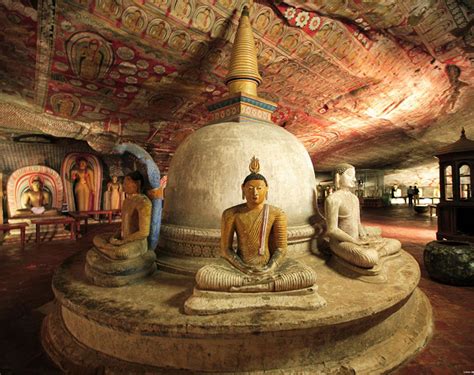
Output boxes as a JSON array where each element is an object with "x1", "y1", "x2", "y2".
[{"x1": 225, "y1": 6, "x2": 262, "y2": 96}]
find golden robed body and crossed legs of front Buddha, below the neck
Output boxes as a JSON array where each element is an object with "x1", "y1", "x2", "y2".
[{"x1": 196, "y1": 204, "x2": 316, "y2": 292}]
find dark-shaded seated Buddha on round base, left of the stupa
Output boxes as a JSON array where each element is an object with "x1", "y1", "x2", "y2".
[{"x1": 85, "y1": 172, "x2": 156, "y2": 286}]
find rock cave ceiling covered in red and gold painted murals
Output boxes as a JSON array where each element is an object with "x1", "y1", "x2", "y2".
[{"x1": 0, "y1": 0, "x2": 474, "y2": 170}]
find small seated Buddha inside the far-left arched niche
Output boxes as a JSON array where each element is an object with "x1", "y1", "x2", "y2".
[{"x1": 15, "y1": 175, "x2": 58, "y2": 217}]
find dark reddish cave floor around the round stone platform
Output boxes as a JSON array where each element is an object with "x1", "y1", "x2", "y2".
[{"x1": 0, "y1": 206, "x2": 474, "y2": 375}]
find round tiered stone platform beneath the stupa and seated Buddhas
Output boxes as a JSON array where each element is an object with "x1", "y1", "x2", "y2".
[{"x1": 42, "y1": 252, "x2": 432, "y2": 374}]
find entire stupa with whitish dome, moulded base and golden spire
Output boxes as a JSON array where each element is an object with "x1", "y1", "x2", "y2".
[{"x1": 158, "y1": 9, "x2": 316, "y2": 273}]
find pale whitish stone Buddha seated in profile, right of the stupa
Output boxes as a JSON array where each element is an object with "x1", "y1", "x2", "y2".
[{"x1": 325, "y1": 164, "x2": 401, "y2": 275}]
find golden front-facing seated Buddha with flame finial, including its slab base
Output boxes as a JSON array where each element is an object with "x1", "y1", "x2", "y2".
[{"x1": 185, "y1": 157, "x2": 324, "y2": 315}]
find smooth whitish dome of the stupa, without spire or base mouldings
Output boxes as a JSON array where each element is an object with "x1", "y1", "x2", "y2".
[{"x1": 163, "y1": 121, "x2": 316, "y2": 229}]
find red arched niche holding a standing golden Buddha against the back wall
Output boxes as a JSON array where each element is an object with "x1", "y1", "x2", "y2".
[{"x1": 61, "y1": 152, "x2": 103, "y2": 211}]
